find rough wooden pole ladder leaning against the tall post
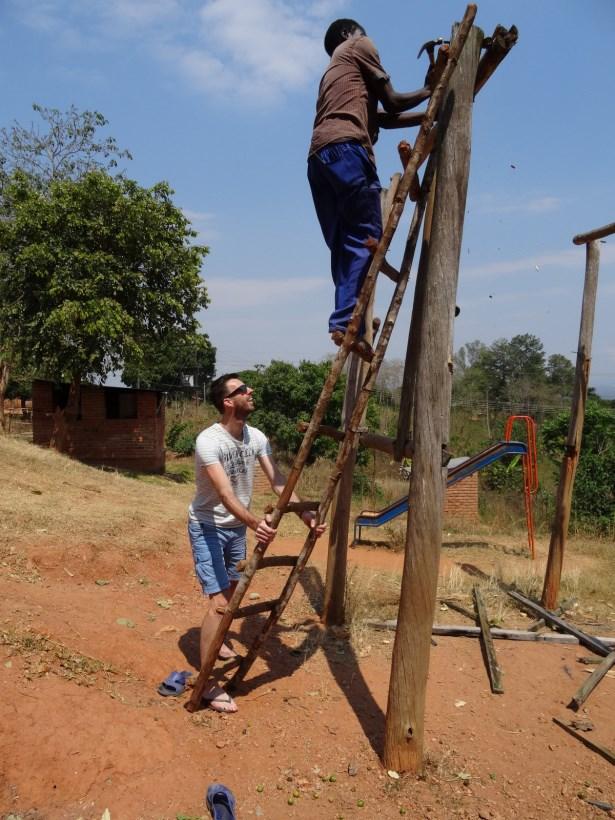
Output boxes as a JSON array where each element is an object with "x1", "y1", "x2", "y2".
[{"x1": 186, "y1": 18, "x2": 472, "y2": 712}]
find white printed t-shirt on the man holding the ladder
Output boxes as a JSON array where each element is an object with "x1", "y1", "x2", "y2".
[{"x1": 188, "y1": 423, "x2": 271, "y2": 527}]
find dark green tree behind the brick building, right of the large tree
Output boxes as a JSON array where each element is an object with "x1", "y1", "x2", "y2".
[{"x1": 122, "y1": 330, "x2": 216, "y2": 392}]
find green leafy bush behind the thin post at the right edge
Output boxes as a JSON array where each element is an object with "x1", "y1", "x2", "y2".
[{"x1": 541, "y1": 400, "x2": 615, "y2": 533}]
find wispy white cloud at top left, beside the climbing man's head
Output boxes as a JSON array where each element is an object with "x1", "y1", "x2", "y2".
[{"x1": 10, "y1": 0, "x2": 332, "y2": 105}]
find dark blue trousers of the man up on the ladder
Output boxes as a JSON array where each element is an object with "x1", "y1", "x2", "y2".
[{"x1": 308, "y1": 142, "x2": 382, "y2": 334}]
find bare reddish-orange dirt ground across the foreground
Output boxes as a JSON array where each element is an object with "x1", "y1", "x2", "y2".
[{"x1": 0, "y1": 527, "x2": 615, "y2": 820}]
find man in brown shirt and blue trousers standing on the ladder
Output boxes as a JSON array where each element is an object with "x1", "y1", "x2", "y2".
[{"x1": 308, "y1": 19, "x2": 437, "y2": 360}]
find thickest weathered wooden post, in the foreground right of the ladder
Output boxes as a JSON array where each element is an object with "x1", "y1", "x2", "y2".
[{"x1": 384, "y1": 22, "x2": 483, "y2": 771}]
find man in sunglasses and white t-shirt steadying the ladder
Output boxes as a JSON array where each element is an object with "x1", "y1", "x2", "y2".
[{"x1": 188, "y1": 373, "x2": 325, "y2": 712}]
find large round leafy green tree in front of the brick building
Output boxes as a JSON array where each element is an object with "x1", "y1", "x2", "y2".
[{"x1": 0, "y1": 171, "x2": 208, "y2": 449}]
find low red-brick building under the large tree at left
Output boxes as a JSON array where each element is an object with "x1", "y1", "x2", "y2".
[{"x1": 32, "y1": 379, "x2": 165, "y2": 473}]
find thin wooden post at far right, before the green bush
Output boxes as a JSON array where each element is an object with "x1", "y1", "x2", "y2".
[{"x1": 542, "y1": 224, "x2": 615, "y2": 609}]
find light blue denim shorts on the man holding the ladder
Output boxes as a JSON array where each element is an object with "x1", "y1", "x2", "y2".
[{"x1": 188, "y1": 521, "x2": 246, "y2": 595}]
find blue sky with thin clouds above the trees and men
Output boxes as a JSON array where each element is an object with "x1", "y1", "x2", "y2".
[{"x1": 0, "y1": 0, "x2": 615, "y2": 395}]
